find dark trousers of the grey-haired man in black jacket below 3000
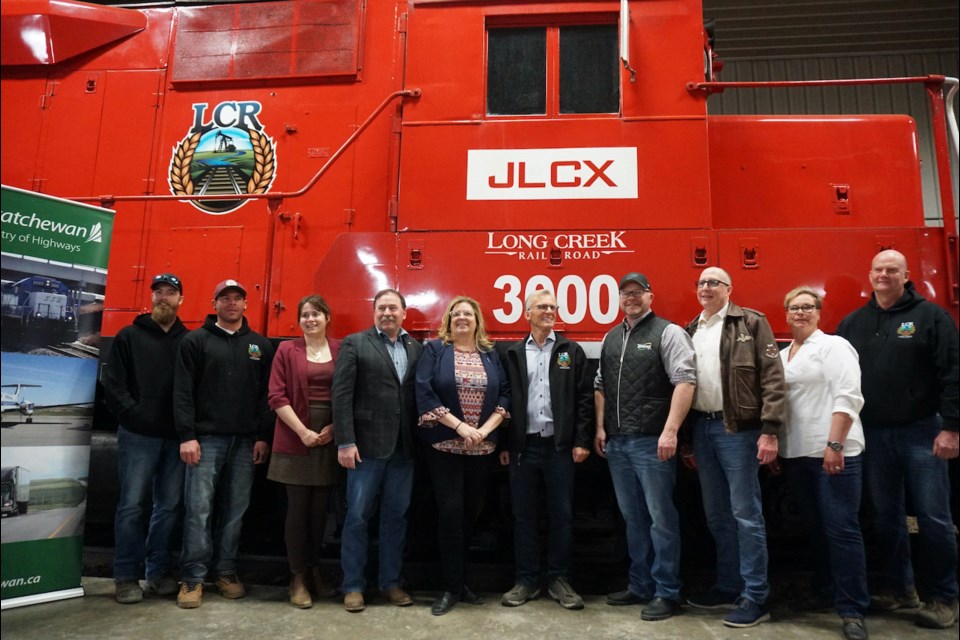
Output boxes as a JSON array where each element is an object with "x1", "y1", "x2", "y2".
[{"x1": 510, "y1": 435, "x2": 575, "y2": 587}]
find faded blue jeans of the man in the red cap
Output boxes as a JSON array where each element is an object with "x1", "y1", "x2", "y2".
[{"x1": 180, "y1": 436, "x2": 254, "y2": 583}]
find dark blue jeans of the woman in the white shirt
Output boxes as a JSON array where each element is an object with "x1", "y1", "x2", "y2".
[{"x1": 783, "y1": 455, "x2": 870, "y2": 618}]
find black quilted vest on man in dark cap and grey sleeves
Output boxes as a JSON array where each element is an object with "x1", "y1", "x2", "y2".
[{"x1": 600, "y1": 312, "x2": 673, "y2": 436}]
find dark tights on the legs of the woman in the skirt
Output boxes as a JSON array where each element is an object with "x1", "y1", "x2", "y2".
[{"x1": 283, "y1": 484, "x2": 331, "y2": 573}]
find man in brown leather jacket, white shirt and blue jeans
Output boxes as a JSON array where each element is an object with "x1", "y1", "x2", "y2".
[{"x1": 684, "y1": 267, "x2": 785, "y2": 628}]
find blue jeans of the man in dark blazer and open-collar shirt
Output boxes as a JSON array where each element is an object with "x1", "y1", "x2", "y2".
[{"x1": 340, "y1": 451, "x2": 413, "y2": 593}]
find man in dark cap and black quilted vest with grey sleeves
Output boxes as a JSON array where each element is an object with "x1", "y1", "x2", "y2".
[{"x1": 594, "y1": 272, "x2": 697, "y2": 621}]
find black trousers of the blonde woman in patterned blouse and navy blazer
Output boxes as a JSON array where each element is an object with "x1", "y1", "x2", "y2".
[{"x1": 424, "y1": 447, "x2": 494, "y2": 594}]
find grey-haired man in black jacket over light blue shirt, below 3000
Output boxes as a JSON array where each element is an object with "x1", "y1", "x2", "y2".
[{"x1": 500, "y1": 289, "x2": 593, "y2": 609}]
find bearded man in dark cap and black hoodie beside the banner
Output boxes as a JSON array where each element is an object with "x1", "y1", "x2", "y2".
[{"x1": 102, "y1": 273, "x2": 187, "y2": 604}]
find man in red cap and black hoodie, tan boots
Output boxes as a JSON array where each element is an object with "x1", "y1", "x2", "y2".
[{"x1": 174, "y1": 280, "x2": 273, "y2": 609}]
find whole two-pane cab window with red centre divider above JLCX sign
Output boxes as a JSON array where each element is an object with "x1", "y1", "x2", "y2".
[{"x1": 487, "y1": 24, "x2": 620, "y2": 116}]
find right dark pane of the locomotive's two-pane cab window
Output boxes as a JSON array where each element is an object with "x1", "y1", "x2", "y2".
[{"x1": 560, "y1": 24, "x2": 620, "y2": 113}]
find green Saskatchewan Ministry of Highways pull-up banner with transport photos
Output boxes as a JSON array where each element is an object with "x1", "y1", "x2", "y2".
[{"x1": 0, "y1": 186, "x2": 113, "y2": 609}]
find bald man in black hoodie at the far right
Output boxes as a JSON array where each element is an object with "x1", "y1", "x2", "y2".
[{"x1": 837, "y1": 249, "x2": 960, "y2": 629}]
